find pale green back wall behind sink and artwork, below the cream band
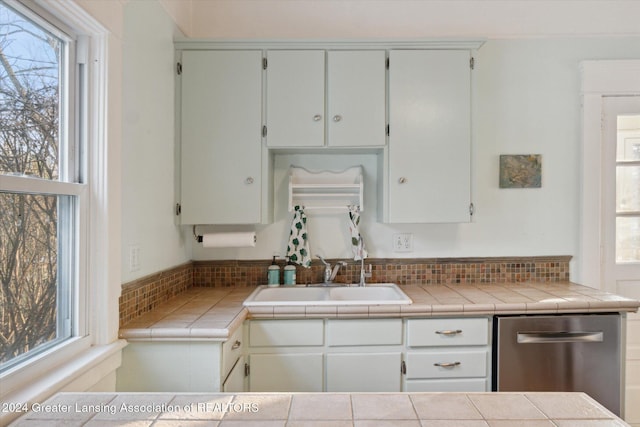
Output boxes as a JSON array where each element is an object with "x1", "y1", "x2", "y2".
[{"x1": 194, "y1": 37, "x2": 640, "y2": 280}]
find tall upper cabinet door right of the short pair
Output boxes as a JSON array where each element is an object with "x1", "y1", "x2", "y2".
[{"x1": 388, "y1": 50, "x2": 471, "y2": 223}]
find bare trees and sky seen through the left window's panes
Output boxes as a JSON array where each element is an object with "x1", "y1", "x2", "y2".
[{"x1": 0, "y1": 4, "x2": 61, "y2": 367}]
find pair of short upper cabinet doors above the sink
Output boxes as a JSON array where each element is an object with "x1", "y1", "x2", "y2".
[{"x1": 265, "y1": 50, "x2": 386, "y2": 147}]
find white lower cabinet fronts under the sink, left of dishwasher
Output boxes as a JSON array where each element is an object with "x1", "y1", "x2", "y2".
[{"x1": 247, "y1": 317, "x2": 491, "y2": 392}]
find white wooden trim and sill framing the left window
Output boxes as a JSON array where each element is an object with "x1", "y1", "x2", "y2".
[{"x1": 0, "y1": 0, "x2": 126, "y2": 425}]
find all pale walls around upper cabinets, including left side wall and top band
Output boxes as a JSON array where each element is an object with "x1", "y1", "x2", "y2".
[{"x1": 117, "y1": 0, "x2": 640, "y2": 282}]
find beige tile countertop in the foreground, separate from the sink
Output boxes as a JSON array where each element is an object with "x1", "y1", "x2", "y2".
[{"x1": 12, "y1": 393, "x2": 628, "y2": 427}]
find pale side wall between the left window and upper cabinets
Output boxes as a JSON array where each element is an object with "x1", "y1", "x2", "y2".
[{"x1": 121, "y1": 1, "x2": 190, "y2": 283}]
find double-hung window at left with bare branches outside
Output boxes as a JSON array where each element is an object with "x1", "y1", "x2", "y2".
[{"x1": 0, "y1": 2, "x2": 86, "y2": 372}]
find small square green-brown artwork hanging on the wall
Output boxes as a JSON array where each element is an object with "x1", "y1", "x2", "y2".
[{"x1": 500, "y1": 154, "x2": 542, "y2": 188}]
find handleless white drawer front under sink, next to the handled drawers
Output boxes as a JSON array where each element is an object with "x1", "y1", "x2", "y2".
[{"x1": 327, "y1": 319, "x2": 402, "y2": 347}]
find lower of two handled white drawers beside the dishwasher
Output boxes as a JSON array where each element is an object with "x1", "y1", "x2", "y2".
[{"x1": 406, "y1": 350, "x2": 489, "y2": 379}]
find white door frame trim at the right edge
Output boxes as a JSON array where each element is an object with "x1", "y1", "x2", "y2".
[{"x1": 577, "y1": 60, "x2": 640, "y2": 292}]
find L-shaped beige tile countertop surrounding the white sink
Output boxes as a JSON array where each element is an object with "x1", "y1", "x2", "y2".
[{"x1": 120, "y1": 282, "x2": 640, "y2": 341}]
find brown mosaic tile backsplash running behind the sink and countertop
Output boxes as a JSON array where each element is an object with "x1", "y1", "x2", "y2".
[{"x1": 120, "y1": 256, "x2": 571, "y2": 325}]
